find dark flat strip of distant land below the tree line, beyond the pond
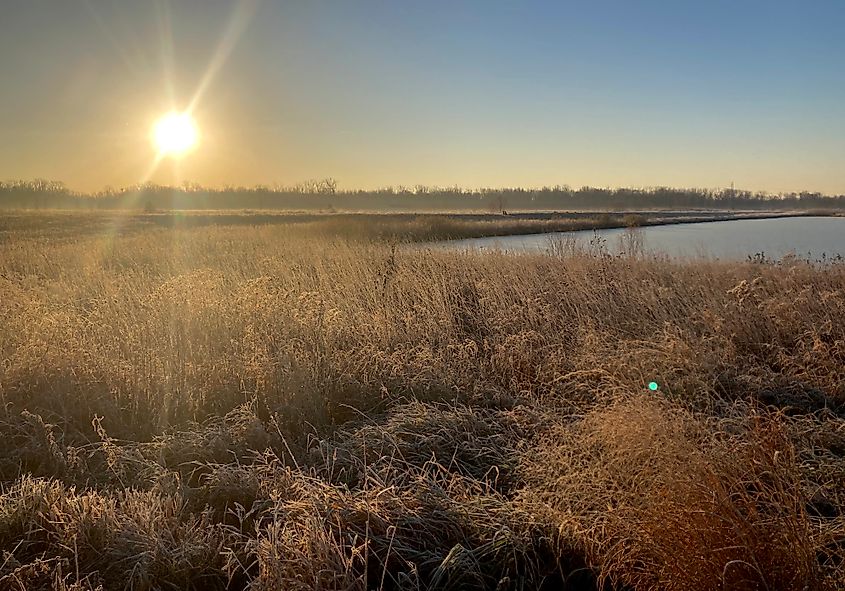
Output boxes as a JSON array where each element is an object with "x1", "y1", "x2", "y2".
[{"x1": 0, "y1": 210, "x2": 840, "y2": 242}]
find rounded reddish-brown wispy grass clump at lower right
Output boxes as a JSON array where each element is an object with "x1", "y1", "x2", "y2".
[{"x1": 523, "y1": 398, "x2": 821, "y2": 590}]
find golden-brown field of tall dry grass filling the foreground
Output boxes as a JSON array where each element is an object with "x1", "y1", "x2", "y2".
[{"x1": 0, "y1": 213, "x2": 845, "y2": 591}]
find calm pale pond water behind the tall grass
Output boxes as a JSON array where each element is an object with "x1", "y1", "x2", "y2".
[{"x1": 434, "y1": 217, "x2": 845, "y2": 260}]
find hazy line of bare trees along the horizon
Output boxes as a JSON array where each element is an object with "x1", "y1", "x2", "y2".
[{"x1": 0, "y1": 178, "x2": 845, "y2": 213}]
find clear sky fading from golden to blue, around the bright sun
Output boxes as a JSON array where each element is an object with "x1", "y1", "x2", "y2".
[{"x1": 0, "y1": 0, "x2": 845, "y2": 194}]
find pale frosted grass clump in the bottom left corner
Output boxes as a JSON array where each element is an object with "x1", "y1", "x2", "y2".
[{"x1": 0, "y1": 477, "x2": 234, "y2": 589}]
